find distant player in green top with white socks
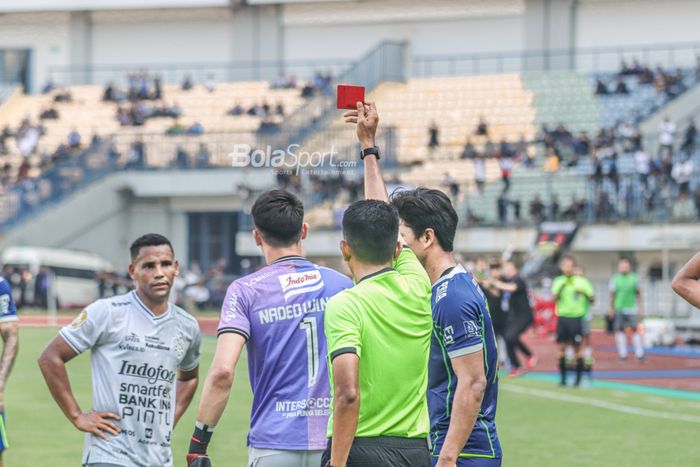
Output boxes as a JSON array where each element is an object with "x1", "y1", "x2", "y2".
[{"x1": 608, "y1": 258, "x2": 644, "y2": 360}]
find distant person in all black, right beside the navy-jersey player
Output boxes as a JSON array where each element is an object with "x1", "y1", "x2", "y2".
[{"x1": 489, "y1": 261, "x2": 537, "y2": 376}]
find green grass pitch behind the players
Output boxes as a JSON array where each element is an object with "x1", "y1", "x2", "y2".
[{"x1": 3, "y1": 328, "x2": 700, "y2": 467}]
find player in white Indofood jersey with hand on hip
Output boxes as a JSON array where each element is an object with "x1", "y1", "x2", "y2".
[{"x1": 39, "y1": 234, "x2": 201, "y2": 467}]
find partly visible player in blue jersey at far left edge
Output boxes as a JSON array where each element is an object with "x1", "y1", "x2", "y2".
[{"x1": 0, "y1": 277, "x2": 19, "y2": 467}]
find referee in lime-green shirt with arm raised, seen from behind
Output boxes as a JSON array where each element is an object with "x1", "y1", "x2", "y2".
[{"x1": 321, "y1": 103, "x2": 432, "y2": 467}]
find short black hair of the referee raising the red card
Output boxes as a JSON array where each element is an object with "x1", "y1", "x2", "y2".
[{"x1": 343, "y1": 199, "x2": 399, "y2": 264}]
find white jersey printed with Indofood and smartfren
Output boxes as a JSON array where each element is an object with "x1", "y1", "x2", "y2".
[{"x1": 60, "y1": 291, "x2": 201, "y2": 467}]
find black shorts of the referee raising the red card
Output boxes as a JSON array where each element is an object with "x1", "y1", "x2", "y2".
[{"x1": 321, "y1": 436, "x2": 431, "y2": 467}]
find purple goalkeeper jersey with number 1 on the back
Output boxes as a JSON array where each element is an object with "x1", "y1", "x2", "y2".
[{"x1": 218, "y1": 256, "x2": 353, "y2": 450}]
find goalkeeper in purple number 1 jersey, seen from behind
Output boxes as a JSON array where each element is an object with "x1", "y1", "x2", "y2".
[{"x1": 187, "y1": 190, "x2": 352, "y2": 467}]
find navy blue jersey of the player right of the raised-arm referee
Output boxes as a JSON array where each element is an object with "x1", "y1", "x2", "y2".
[{"x1": 428, "y1": 266, "x2": 502, "y2": 458}]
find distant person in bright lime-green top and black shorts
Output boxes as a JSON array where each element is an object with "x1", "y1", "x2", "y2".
[{"x1": 552, "y1": 255, "x2": 594, "y2": 386}]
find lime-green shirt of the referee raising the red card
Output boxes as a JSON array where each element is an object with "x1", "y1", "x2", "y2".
[{"x1": 324, "y1": 247, "x2": 433, "y2": 438}]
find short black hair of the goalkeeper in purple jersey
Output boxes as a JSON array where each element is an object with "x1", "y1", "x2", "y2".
[{"x1": 251, "y1": 190, "x2": 304, "y2": 247}]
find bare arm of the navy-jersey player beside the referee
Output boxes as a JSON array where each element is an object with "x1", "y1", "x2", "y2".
[{"x1": 436, "y1": 350, "x2": 486, "y2": 467}]
